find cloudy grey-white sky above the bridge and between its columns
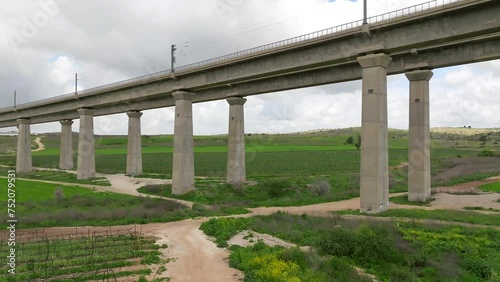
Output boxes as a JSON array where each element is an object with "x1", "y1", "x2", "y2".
[{"x1": 0, "y1": 0, "x2": 500, "y2": 134}]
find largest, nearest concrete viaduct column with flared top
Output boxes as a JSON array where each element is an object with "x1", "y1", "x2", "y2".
[{"x1": 358, "y1": 54, "x2": 391, "y2": 213}]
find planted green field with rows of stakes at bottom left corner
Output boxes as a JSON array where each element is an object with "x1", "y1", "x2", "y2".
[{"x1": 0, "y1": 232, "x2": 160, "y2": 281}]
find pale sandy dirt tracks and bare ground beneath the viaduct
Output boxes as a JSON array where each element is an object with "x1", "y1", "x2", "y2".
[{"x1": 0, "y1": 172, "x2": 500, "y2": 282}]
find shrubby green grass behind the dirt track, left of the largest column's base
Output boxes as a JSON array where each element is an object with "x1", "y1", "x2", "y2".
[{"x1": 137, "y1": 175, "x2": 359, "y2": 207}]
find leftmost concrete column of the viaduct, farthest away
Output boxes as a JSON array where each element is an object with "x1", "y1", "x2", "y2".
[{"x1": 16, "y1": 118, "x2": 33, "y2": 173}]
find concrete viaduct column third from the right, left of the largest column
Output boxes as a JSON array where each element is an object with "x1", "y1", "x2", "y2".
[{"x1": 226, "y1": 97, "x2": 247, "y2": 184}]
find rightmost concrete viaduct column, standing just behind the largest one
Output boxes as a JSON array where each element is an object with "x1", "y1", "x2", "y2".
[{"x1": 406, "y1": 70, "x2": 433, "y2": 201}]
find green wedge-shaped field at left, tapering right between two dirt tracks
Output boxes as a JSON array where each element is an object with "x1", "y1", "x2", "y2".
[{"x1": 0, "y1": 178, "x2": 248, "y2": 228}]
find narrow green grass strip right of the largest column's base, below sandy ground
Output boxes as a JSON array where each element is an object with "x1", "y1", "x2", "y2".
[{"x1": 335, "y1": 209, "x2": 500, "y2": 226}]
